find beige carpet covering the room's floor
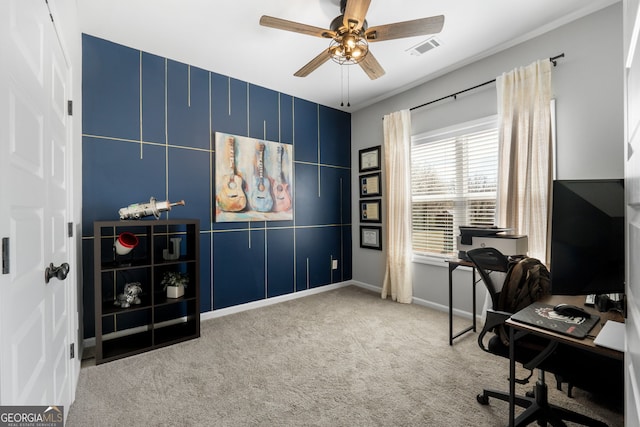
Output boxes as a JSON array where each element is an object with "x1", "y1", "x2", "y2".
[{"x1": 67, "y1": 286, "x2": 624, "y2": 427}]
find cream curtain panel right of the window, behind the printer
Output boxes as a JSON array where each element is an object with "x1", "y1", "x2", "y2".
[{"x1": 496, "y1": 59, "x2": 553, "y2": 263}]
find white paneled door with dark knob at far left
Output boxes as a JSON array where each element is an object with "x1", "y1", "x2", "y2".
[{"x1": 0, "y1": 0, "x2": 76, "y2": 412}]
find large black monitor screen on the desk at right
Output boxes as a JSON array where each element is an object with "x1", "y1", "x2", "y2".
[{"x1": 551, "y1": 180, "x2": 625, "y2": 295}]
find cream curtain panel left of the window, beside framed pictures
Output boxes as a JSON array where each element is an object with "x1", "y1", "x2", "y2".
[{"x1": 382, "y1": 110, "x2": 413, "y2": 304}]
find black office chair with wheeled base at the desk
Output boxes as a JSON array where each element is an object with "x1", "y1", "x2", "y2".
[{"x1": 467, "y1": 248, "x2": 606, "y2": 427}]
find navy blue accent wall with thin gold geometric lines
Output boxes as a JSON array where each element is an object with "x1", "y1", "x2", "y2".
[{"x1": 82, "y1": 35, "x2": 351, "y2": 337}]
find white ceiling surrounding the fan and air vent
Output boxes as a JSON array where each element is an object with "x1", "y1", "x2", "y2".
[{"x1": 77, "y1": 0, "x2": 619, "y2": 111}]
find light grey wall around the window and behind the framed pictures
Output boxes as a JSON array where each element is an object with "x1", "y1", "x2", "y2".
[{"x1": 352, "y1": 2, "x2": 624, "y2": 312}]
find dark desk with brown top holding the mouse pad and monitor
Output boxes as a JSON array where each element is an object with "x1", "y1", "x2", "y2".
[{"x1": 506, "y1": 295, "x2": 624, "y2": 426}]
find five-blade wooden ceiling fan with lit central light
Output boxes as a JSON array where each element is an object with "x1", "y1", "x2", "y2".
[{"x1": 260, "y1": 0, "x2": 444, "y2": 80}]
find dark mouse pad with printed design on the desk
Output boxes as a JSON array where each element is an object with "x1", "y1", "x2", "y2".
[{"x1": 511, "y1": 302, "x2": 600, "y2": 338}]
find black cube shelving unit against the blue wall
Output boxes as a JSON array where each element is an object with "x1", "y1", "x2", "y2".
[{"x1": 93, "y1": 219, "x2": 200, "y2": 364}]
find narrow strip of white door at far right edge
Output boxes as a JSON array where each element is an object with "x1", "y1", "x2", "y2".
[{"x1": 624, "y1": 0, "x2": 640, "y2": 426}]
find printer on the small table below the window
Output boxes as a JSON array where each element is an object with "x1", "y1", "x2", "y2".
[{"x1": 457, "y1": 226, "x2": 529, "y2": 260}]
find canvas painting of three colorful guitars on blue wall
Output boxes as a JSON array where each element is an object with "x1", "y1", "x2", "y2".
[{"x1": 215, "y1": 132, "x2": 293, "y2": 222}]
